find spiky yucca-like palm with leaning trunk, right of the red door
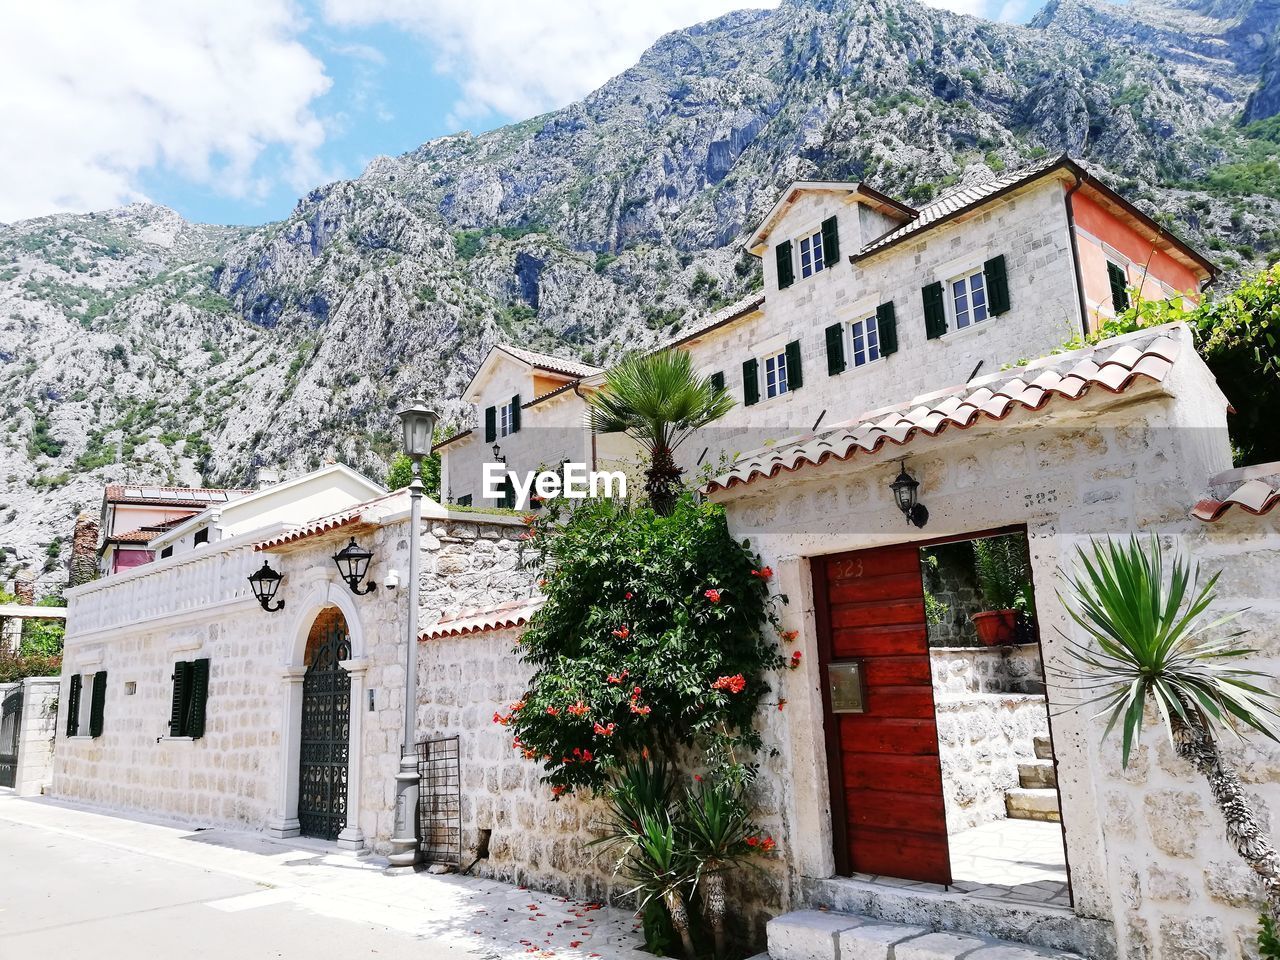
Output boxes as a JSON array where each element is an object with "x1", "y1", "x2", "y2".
[{"x1": 1062, "y1": 536, "x2": 1280, "y2": 918}]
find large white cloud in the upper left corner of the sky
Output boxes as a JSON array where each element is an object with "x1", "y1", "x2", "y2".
[{"x1": 0, "y1": 0, "x2": 329, "y2": 221}]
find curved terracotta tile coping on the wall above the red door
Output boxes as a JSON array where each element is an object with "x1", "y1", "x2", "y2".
[{"x1": 703, "y1": 328, "x2": 1180, "y2": 493}]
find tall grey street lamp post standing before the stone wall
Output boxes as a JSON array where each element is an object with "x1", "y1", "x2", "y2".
[{"x1": 387, "y1": 401, "x2": 436, "y2": 869}]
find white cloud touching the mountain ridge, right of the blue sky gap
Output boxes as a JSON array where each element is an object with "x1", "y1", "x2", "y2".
[{"x1": 324, "y1": 0, "x2": 777, "y2": 123}]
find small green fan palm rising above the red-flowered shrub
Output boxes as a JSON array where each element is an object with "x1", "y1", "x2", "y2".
[{"x1": 589, "y1": 351, "x2": 733, "y2": 515}]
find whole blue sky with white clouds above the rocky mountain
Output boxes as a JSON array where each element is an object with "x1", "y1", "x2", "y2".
[{"x1": 0, "y1": 0, "x2": 1038, "y2": 224}]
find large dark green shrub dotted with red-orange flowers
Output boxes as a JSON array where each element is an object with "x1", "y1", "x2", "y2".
[{"x1": 506, "y1": 498, "x2": 788, "y2": 796}]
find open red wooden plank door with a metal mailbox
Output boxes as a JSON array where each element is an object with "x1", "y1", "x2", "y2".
[{"x1": 813, "y1": 547, "x2": 951, "y2": 883}]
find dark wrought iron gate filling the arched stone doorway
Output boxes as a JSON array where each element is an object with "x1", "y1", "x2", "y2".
[{"x1": 298, "y1": 617, "x2": 351, "y2": 840}]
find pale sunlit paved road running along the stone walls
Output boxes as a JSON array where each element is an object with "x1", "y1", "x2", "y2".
[{"x1": 0, "y1": 795, "x2": 646, "y2": 960}]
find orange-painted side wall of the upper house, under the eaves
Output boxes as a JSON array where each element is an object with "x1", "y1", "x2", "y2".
[{"x1": 1071, "y1": 188, "x2": 1201, "y2": 329}]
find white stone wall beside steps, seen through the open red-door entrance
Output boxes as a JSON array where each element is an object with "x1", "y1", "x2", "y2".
[{"x1": 934, "y1": 694, "x2": 1048, "y2": 833}]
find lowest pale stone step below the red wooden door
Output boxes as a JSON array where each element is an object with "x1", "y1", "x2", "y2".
[{"x1": 767, "y1": 910, "x2": 1079, "y2": 960}]
